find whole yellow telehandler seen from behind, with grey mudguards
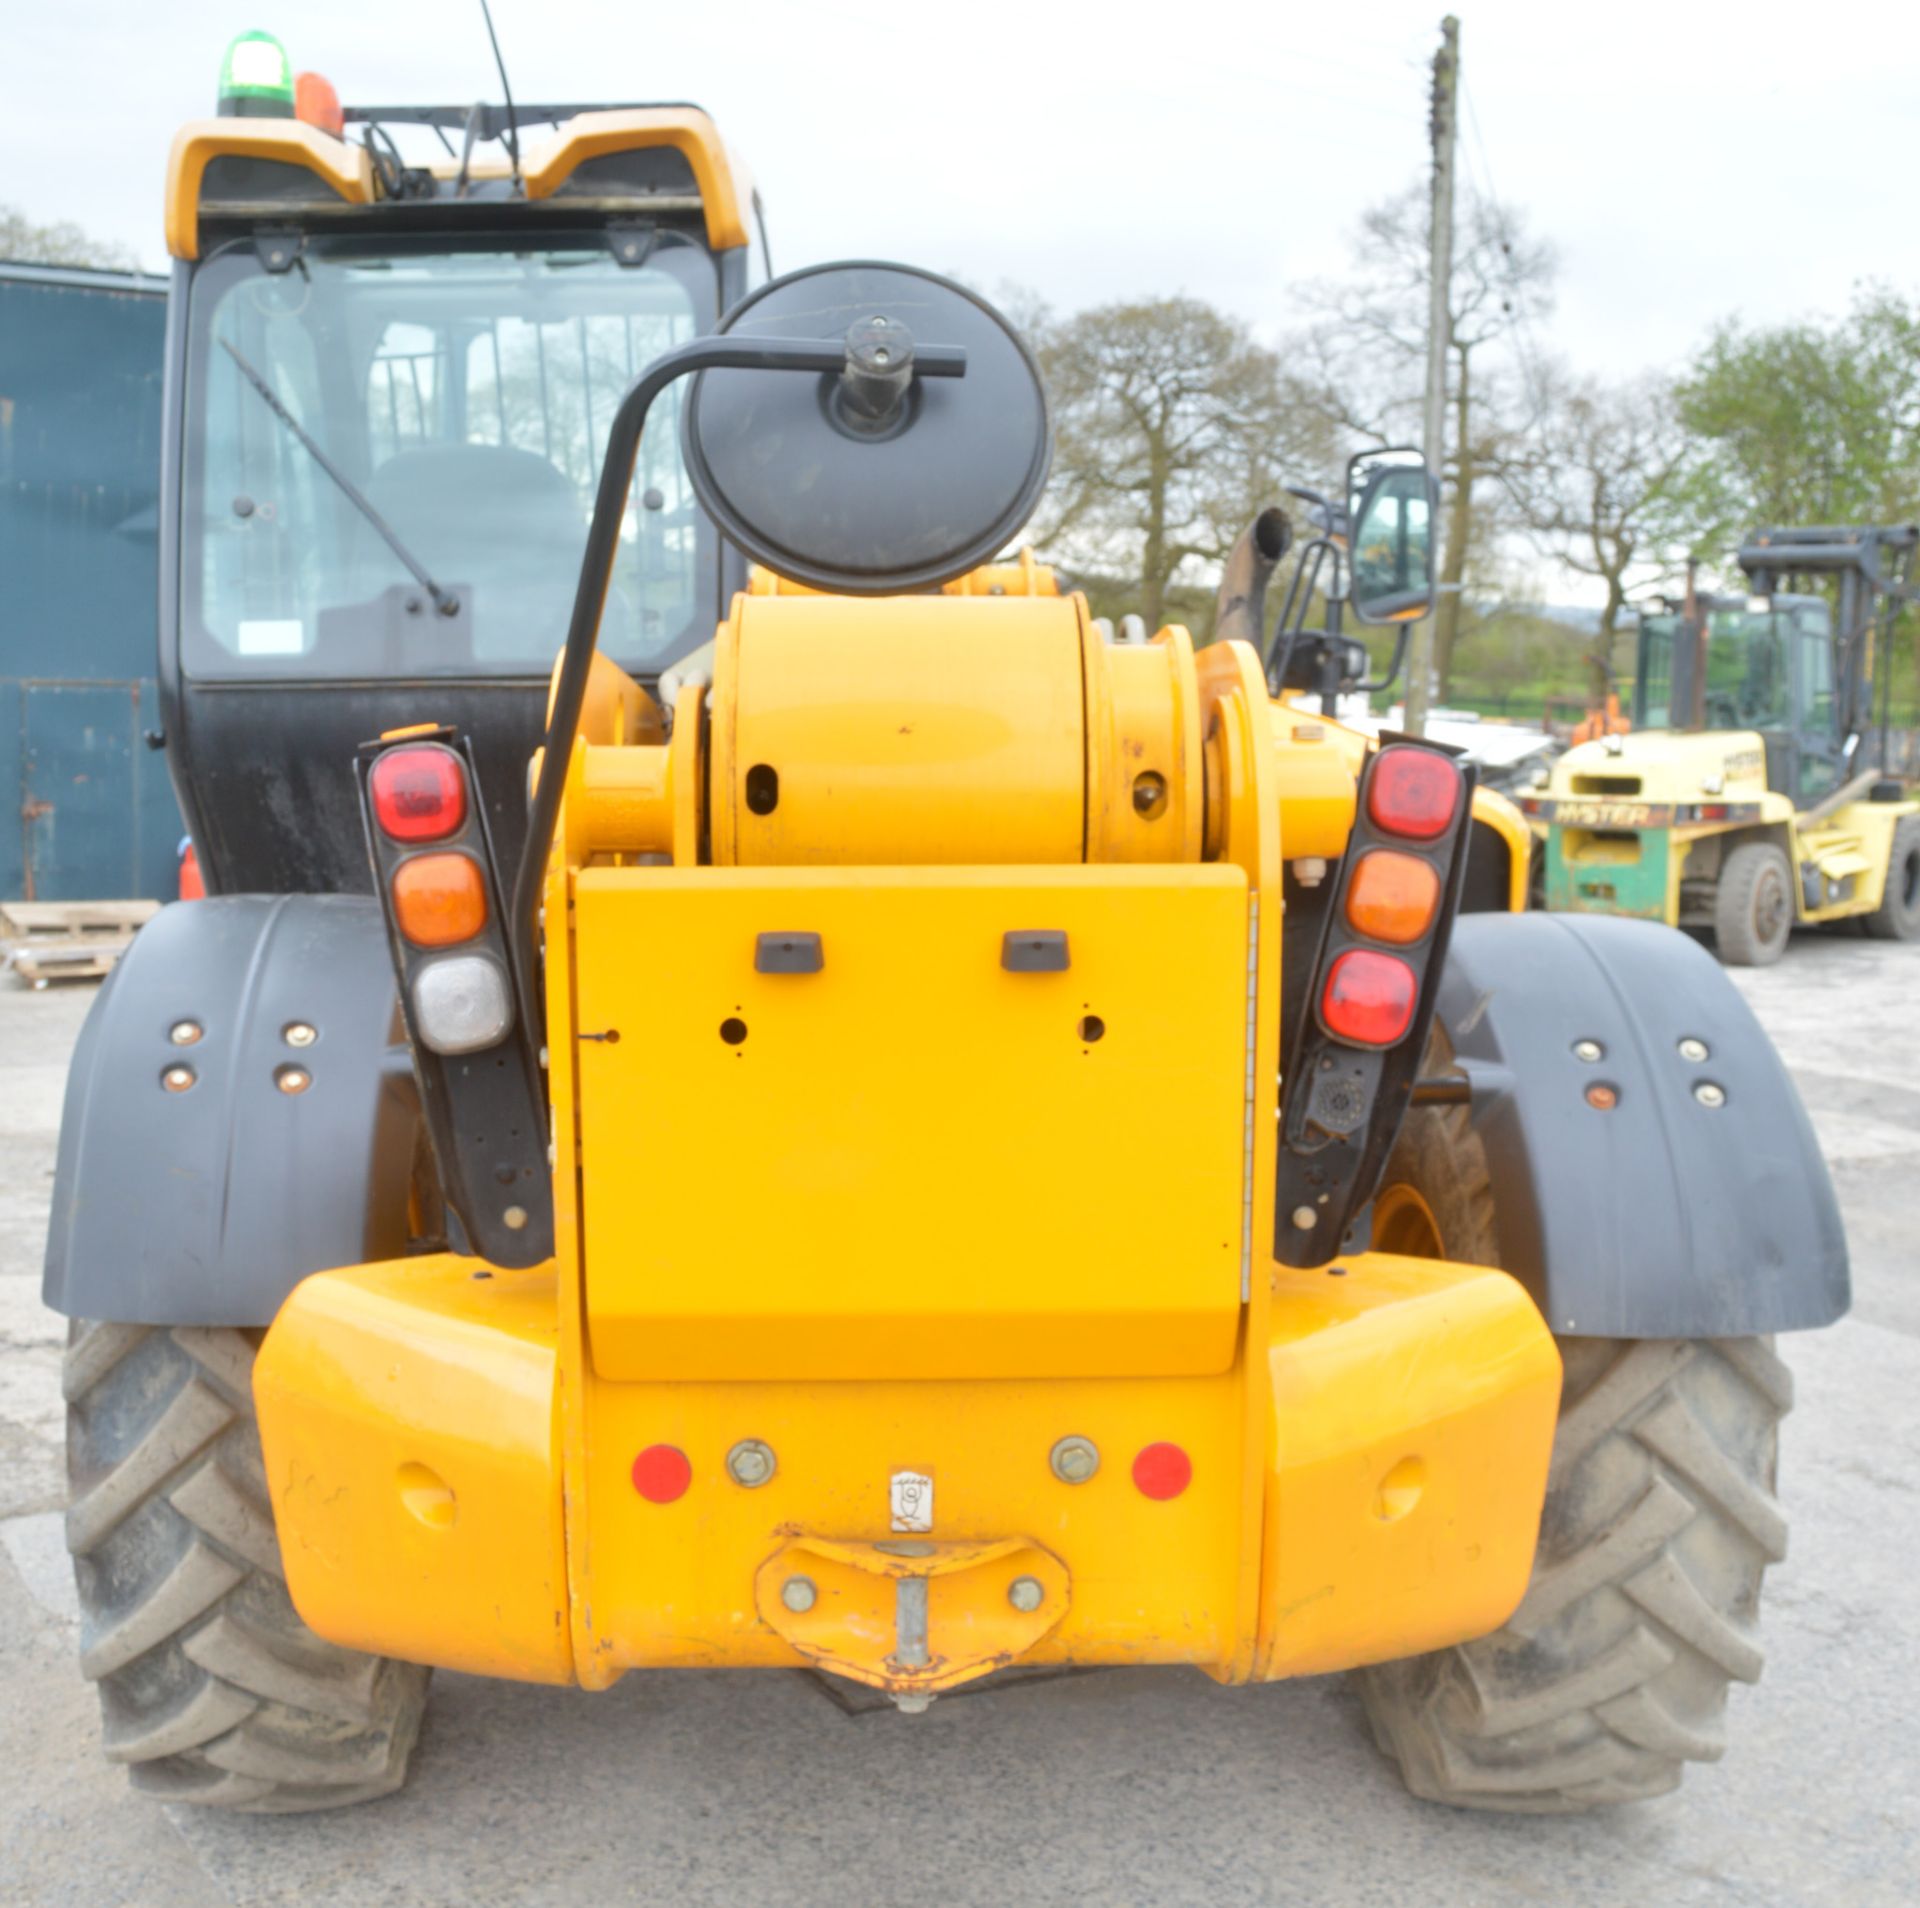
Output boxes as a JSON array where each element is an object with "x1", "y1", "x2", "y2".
[{"x1": 46, "y1": 37, "x2": 1847, "y2": 1810}]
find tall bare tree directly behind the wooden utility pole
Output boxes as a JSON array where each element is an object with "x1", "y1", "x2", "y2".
[{"x1": 1290, "y1": 184, "x2": 1555, "y2": 697}]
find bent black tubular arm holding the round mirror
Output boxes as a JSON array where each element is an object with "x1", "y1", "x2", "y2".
[{"x1": 507, "y1": 332, "x2": 966, "y2": 1029}]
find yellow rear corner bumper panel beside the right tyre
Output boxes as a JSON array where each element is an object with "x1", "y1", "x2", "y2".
[{"x1": 1258, "y1": 1253, "x2": 1561, "y2": 1678}]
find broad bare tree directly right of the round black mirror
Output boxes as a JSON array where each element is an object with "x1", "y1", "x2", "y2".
[{"x1": 1025, "y1": 298, "x2": 1334, "y2": 630}]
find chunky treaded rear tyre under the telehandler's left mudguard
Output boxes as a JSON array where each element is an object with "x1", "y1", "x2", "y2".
[{"x1": 63, "y1": 1321, "x2": 430, "y2": 1814}]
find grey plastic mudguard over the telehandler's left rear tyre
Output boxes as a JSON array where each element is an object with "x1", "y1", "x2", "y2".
[{"x1": 46, "y1": 894, "x2": 420, "y2": 1326}]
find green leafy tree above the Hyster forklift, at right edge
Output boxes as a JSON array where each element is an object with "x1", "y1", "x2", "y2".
[{"x1": 1678, "y1": 286, "x2": 1920, "y2": 559}]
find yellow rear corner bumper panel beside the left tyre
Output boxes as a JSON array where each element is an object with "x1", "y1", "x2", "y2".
[{"x1": 253, "y1": 1255, "x2": 574, "y2": 1683}]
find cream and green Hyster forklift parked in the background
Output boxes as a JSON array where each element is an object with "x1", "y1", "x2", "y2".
[{"x1": 1521, "y1": 524, "x2": 1920, "y2": 967}]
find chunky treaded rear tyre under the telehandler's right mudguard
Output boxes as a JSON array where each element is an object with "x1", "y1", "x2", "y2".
[{"x1": 1357, "y1": 1074, "x2": 1793, "y2": 1814}]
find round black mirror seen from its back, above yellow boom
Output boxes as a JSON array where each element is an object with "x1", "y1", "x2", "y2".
[{"x1": 684, "y1": 263, "x2": 1052, "y2": 597}]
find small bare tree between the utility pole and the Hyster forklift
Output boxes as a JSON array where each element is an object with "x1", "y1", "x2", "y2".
[{"x1": 1503, "y1": 376, "x2": 1690, "y2": 701}]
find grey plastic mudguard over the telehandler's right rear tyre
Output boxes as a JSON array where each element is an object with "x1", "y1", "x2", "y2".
[{"x1": 1438, "y1": 914, "x2": 1851, "y2": 1338}]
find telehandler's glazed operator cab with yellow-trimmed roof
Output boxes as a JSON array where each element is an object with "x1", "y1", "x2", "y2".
[{"x1": 159, "y1": 89, "x2": 768, "y2": 894}]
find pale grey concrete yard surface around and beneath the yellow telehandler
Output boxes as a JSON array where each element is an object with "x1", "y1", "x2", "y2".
[{"x1": 0, "y1": 935, "x2": 1920, "y2": 1908}]
